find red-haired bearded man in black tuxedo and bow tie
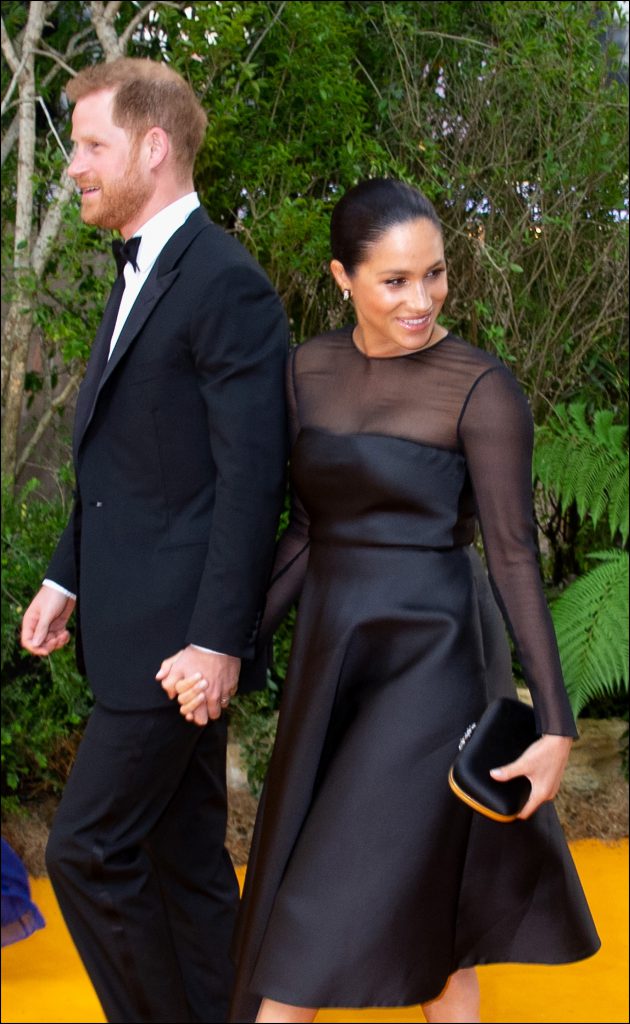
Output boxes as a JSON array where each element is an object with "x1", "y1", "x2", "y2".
[{"x1": 22, "y1": 58, "x2": 287, "y2": 1024}]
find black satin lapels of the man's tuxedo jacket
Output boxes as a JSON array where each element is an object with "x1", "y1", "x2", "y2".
[{"x1": 74, "y1": 207, "x2": 210, "y2": 452}]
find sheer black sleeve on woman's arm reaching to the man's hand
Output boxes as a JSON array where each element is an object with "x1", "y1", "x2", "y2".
[{"x1": 259, "y1": 350, "x2": 309, "y2": 644}]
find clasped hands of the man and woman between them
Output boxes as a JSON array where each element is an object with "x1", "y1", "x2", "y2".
[{"x1": 156, "y1": 646, "x2": 241, "y2": 726}]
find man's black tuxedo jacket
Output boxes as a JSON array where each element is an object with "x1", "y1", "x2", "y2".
[{"x1": 47, "y1": 203, "x2": 288, "y2": 709}]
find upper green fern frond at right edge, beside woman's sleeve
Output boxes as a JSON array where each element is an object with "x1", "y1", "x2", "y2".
[{"x1": 534, "y1": 402, "x2": 629, "y2": 544}]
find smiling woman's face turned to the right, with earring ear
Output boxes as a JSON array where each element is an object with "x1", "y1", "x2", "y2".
[{"x1": 331, "y1": 217, "x2": 449, "y2": 357}]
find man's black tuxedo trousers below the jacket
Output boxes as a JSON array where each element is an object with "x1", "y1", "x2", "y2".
[{"x1": 46, "y1": 706, "x2": 239, "y2": 1024}]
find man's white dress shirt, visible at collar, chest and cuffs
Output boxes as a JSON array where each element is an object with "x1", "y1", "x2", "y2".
[{"x1": 43, "y1": 191, "x2": 224, "y2": 653}]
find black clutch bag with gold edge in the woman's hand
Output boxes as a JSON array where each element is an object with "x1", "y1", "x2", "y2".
[{"x1": 449, "y1": 697, "x2": 538, "y2": 821}]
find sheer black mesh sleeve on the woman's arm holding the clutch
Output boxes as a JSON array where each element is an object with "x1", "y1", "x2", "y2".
[{"x1": 459, "y1": 368, "x2": 577, "y2": 736}]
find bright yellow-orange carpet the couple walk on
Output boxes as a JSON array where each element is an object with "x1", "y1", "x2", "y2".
[{"x1": 2, "y1": 840, "x2": 629, "y2": 1024}]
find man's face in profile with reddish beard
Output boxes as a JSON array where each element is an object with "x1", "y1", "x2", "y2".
[{"x1": 68, "y1": 89, "x2": 154, "y2": 238}]
